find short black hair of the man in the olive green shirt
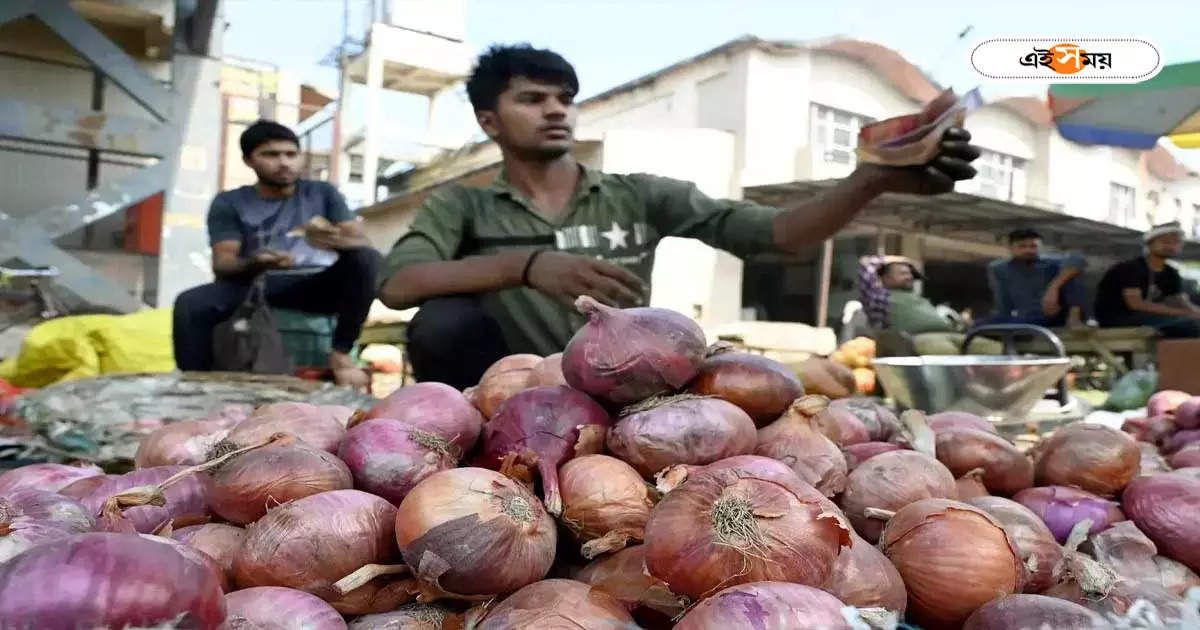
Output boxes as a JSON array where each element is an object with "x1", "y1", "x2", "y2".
[{"x1": 467, "y1": 43, "x2": 580, "y2": 112}]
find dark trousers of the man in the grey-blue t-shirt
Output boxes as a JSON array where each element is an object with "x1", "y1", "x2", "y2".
[{"x1": 173, "y1": 247, "x2": 383, "y2": 371}]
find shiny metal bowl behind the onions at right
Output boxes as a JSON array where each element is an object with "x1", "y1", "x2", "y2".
[{"x1": 874, "y1": 355, "x2": 1070, "y2": 422}]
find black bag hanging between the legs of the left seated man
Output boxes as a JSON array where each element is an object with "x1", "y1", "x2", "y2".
[{"x1": 212, "y1": 275, "x2": 295, "y2": 374}]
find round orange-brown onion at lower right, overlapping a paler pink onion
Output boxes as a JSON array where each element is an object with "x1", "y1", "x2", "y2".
[{"x1": 880, "y1": 499, "x2": 1024, "y2": 630}]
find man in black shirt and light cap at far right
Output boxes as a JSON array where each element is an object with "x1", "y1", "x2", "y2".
[{"x1": 1096, "y1": 223, "x2": 1200, "y2": 337}]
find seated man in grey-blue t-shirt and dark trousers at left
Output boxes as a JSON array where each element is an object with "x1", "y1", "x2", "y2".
[{"x1": 174, "y1": 120, "x2": 380, "y2": 386}]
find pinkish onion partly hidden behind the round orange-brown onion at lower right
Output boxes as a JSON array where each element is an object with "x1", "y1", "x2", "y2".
[{"x1": 841, "y1": 450, "x2": 958, "y2": 542}]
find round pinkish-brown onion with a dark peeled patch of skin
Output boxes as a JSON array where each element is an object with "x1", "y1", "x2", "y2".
[{"x1": 396, "y1": 468, "x2": 558, "y2": 600}]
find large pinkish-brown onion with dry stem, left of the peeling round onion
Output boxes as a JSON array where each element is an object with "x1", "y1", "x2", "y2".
[{"x1": 233, "y1": 490, "x2": 410, "y2": 614}]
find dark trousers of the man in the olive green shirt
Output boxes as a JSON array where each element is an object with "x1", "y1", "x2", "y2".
[{"x1": 407, "y1": 295, "x2": 509, "y2": 390}]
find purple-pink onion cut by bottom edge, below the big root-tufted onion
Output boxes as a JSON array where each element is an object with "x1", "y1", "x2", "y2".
[{"x1": 676, "y1": 582, "x2": 850, "y2": 630}]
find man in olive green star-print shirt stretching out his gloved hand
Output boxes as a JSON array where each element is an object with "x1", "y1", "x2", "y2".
[{"x1": 379, "y1": 46, "x2": 979, "y2": 389}]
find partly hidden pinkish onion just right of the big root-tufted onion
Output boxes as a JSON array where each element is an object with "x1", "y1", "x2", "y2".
[{"x1": 821, "y1": 534, "x2": 908, "y2": 618}]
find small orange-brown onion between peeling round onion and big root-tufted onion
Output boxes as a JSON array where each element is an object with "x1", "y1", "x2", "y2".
[{"x1": 558, "y1": 455, "x2": 654, "y2": 559}]
